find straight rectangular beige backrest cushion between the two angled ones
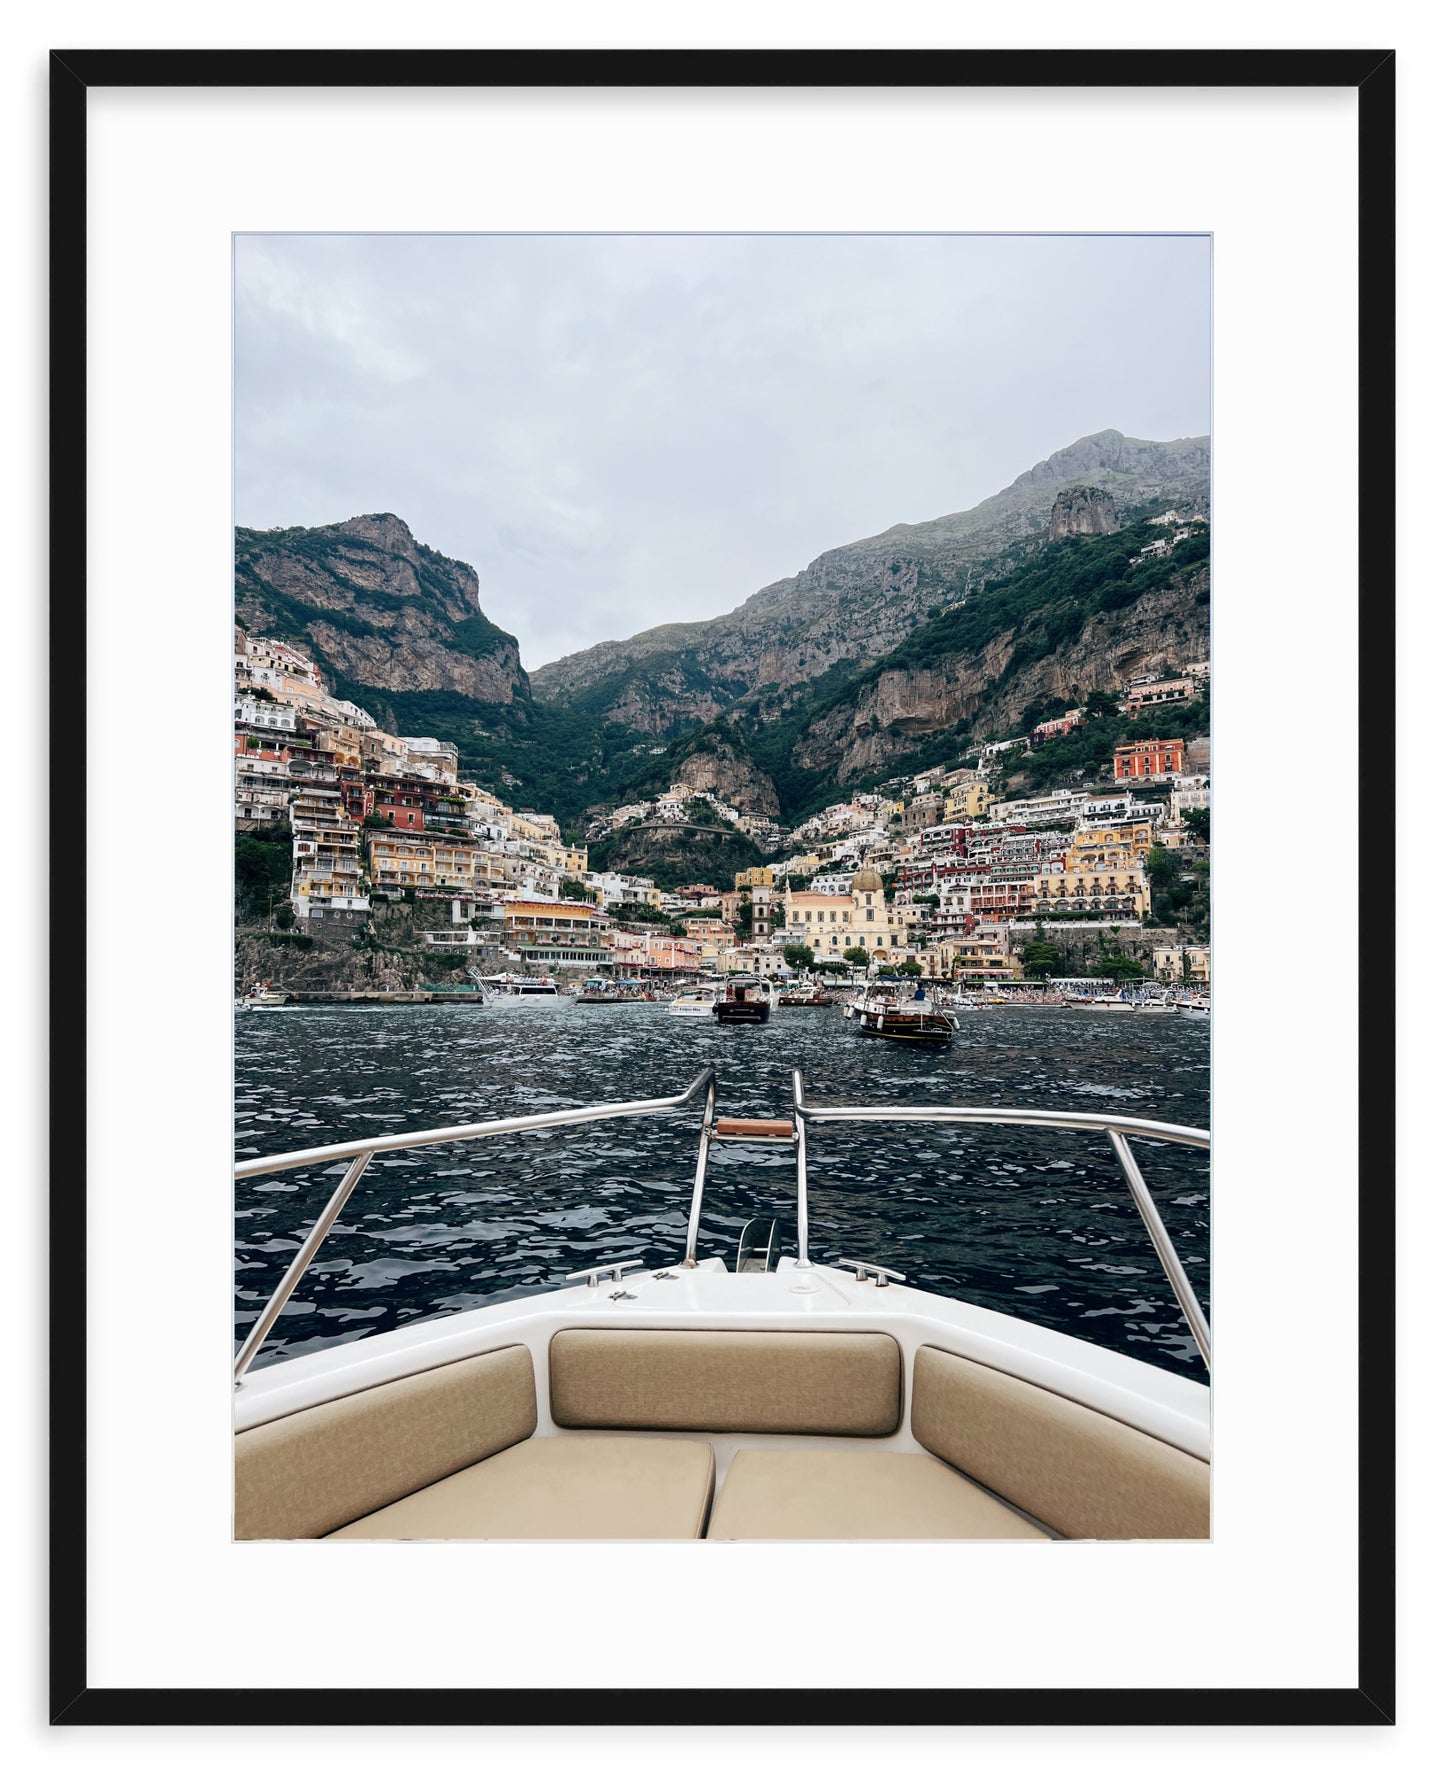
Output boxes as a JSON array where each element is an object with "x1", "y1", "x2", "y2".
[{"x1": 550, "y1": 1328, "x2": 904, "y2": 1436}]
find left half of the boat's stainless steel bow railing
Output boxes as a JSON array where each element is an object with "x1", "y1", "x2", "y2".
[{"x1": 234, "y1": 1067, "x2": 717, "y2": 1386}]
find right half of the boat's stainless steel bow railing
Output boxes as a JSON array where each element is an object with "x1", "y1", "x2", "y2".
[{"x1": 794, "y1": 1070, "x2": 1211, "y2": 1369}]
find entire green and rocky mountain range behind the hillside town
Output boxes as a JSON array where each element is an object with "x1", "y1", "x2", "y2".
[{"x1": 236, "y1": 431, "x2": 1209, "y2": 844}]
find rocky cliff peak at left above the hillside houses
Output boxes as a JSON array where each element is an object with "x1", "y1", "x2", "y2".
[{"x1": 236, "y1": 511, "x2": 529, "y2": 703}]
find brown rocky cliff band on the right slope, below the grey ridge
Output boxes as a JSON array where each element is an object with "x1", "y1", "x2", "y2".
[{"x1": 794, "y1": 566, "x2": 1209, "y2": 783}]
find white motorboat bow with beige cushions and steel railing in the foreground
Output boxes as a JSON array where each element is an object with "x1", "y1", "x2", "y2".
[{"x1": 234, "y1": 1069, "x2": 1211, "y2": 1541}]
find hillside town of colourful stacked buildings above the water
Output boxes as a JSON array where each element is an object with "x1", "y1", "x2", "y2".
[{"x1": 234, "y1": 635, "x2": 1209, "y2": 989}]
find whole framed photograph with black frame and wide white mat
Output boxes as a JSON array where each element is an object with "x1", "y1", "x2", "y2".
[{"x1": 51, "y1": 50, "x2": 1395, "y2": 1725}]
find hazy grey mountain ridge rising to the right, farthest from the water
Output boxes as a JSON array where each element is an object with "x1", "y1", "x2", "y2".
[{"x1": 533, "y1": 431, "x2": 1209, "y2": 737}]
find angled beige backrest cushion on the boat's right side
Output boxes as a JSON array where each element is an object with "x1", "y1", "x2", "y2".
[{"x1": 911, "y1": 1345, "x2": 1209, "y2": 1541}]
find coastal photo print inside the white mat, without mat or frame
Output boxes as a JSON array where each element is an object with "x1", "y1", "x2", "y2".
[{"x1": 233, "y1": 234, "x2": 1212, "y2": 1542}]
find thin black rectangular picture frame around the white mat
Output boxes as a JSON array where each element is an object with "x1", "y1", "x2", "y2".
[{"x1": 50, "y1": 50, "x2": 1395, "y2": 1727}]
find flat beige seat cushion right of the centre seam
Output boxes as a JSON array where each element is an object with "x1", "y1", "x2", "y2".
[{"x1": 708, "y1": 1448, "x2": 1049, "y2": 1541}]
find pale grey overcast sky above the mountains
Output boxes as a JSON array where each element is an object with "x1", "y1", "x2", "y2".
[{"x1": 236, "y1": 234, "x2": 1209, "y2": 667}]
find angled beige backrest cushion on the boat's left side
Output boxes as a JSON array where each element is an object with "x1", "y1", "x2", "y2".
[{"x1": 234, "y1": 1344, "x2": 536, "y2": 1541}]
